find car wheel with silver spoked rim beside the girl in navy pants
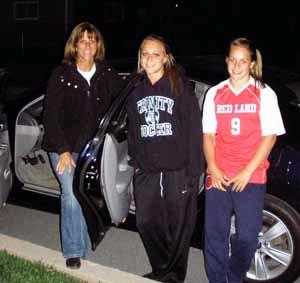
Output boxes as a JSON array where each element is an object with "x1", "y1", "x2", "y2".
[{"x1": 246, "y1": 195, "x2": 300, "y2": 283}]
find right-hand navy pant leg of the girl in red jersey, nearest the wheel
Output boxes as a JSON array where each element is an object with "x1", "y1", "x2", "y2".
[{"x1": 228, "y1": 184, "x2": 265, "y2": 283}]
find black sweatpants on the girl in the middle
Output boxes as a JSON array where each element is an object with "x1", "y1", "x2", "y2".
[{"x1": 134, "y1": 170, "x2": 198, "y2": 282}]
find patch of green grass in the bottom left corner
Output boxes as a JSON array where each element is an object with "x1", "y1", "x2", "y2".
[{"x1": 0, "y1": 251, "x2": 84, "y2": 283}]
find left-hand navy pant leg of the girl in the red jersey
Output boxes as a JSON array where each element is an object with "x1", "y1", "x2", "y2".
[{"x1": 204, "y1": 188, "x2": 232, "y2": 283}]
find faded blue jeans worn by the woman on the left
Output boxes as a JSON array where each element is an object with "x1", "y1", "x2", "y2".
[{"x1": 49, "y1": 152, "x2": 88, "y2": 258}]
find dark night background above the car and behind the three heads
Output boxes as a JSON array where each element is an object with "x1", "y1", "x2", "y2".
[{"x1": 0, "y1": 0, "x2": 300, "y2": 86}]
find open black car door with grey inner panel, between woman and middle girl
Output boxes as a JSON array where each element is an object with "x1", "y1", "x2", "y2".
[{"x1": 73, "y1": 76, "x2": 141, "y2": 250}]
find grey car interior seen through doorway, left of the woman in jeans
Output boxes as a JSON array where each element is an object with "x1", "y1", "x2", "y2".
[{"x1": 14, "y1": 97, "x2": 59, "y2": 195}]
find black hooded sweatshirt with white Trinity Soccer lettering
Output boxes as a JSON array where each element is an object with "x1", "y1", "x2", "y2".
[{"x1": 126, "y1": 71, "x2": 204, "y2": 176}]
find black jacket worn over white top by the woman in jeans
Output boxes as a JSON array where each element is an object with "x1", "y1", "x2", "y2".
[{"x1": 43, "y1": 61, "x2": 124, "y2": 154}]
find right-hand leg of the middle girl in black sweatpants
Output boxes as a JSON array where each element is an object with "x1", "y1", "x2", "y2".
[{"x1": 163, "y1": 170, "x2": 199, "y2": 282}]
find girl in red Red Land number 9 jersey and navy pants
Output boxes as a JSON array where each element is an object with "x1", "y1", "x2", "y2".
[{"x1": 202, "y1": 38, "x2": 285, "y2": 283}]
